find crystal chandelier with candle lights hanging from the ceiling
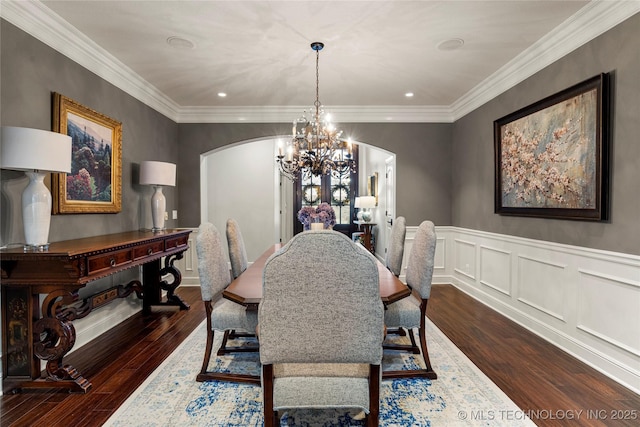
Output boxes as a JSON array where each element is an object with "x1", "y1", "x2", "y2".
[{"x1": 276, "y1": 42, "x2": 356, "y2": 181}]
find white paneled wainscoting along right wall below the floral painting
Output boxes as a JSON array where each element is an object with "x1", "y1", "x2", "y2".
[{"x1": 436, "y1": 226, "x2": 640, "y2": 393}]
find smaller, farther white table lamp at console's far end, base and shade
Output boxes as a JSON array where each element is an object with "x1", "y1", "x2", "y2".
[{"x1": 140, "y1": 161, "x2": 176, "y2": 231}]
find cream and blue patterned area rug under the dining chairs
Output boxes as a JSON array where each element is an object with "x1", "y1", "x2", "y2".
[{"x1": 105, "y1": 319, "x2": 535, "y2": 427}]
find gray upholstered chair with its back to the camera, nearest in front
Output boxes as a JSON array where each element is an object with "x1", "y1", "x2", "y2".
[{"x1": 258, "y1": 230, "x2": 384, "y2": 427}]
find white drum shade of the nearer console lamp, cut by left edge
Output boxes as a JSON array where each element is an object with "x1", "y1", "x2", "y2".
[{"x1": 0, "y1": 126, "x2": 71, "y2": 173}]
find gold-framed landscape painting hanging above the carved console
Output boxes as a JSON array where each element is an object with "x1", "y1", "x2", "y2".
[{"x1": 51, "y1": 93, "x2": 122, "y2": 214}]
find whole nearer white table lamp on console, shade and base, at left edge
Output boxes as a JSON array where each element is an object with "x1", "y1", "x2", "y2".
[{"x1": 0, "y1": 126, "x2": 71, "y2": 251}]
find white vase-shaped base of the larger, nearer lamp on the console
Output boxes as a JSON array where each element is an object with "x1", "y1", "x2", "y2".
[{"x1": 22, "y1": 172, "x2": 51, "y2": 251}]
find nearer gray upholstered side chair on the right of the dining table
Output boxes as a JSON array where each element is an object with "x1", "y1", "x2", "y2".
[{"x1": 382, "y1": 221, "x2": 438, "y2": 379}]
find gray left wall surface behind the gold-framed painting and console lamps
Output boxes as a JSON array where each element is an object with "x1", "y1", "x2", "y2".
[{"x1": 0, "y1": 20, "x2": 180, "y2": 244}]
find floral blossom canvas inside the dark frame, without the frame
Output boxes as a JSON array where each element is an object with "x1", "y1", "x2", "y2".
[{"x1": 501, "y1": 90, "x2": 597, "y2": 209}]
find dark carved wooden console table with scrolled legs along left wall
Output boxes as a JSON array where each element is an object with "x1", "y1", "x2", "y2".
[{"x1": 0, "y1": 230, "x2": 191, "y2": 393}]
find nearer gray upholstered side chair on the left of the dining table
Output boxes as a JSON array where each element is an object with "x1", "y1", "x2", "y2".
[{"x1": 196, "y1": 223, "x2": 260, "y2": 384}]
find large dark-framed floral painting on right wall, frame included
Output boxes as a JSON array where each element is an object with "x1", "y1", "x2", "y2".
[{"x1": 494, "y1": 74, "x2": 609, "y2": 221}]
